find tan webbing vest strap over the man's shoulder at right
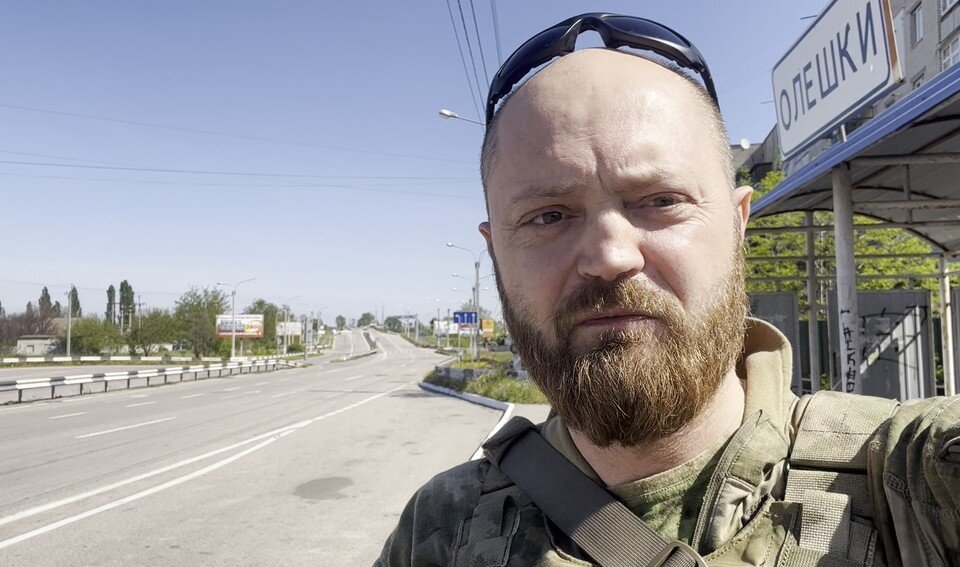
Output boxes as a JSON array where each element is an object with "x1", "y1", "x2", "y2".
[{"x1": 784, "y1": 391, "x2": 899, "y2": 564}]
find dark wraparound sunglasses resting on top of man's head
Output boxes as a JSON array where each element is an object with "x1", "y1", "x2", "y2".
[{"x1": 486, "y1": 12, "x2": 720, "y2": 124}]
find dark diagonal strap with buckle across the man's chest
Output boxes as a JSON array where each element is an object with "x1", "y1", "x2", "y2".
[{"x1": 484, "y1": 417, "x2": 706, "y2": 567}]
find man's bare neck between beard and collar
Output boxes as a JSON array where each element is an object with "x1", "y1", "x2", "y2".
[{"x1": 569, "y1": 371, "x2": 746, "y2": 486}]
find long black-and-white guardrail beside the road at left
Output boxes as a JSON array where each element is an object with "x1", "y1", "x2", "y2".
[{"x1": 0, "y1": 358, "x2": 300, "y2": 404}]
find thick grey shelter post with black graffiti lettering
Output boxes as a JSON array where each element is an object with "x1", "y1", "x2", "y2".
[{"x1": 832, "y1": 163, "x2": 863, "y2": 394}]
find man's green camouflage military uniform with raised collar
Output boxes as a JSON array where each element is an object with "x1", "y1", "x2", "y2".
[{"x1": 376, "y1": 320, "x2": 960, "y2": 567}]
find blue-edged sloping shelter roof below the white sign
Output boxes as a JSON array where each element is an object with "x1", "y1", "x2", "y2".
[{"x1": 752, "y1": 61, "x2": 960, "y2": 251}]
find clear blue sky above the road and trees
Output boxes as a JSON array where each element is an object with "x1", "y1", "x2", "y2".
[{"x1": 0, "y1": 0, "x2": 827, "y2": 322}]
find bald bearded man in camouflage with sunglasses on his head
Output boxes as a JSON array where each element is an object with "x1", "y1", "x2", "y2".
[{"x1": 378, "y1": 14, "x2": 960, "y2": 566}]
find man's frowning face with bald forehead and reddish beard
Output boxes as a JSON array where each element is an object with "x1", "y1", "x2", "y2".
[{"x1": 481, "y1": 50, "x2": 750, "y2": 446}]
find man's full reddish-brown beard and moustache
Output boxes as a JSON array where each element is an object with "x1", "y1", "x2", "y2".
[{"x1": 494, "y1": 246, "x2": 749, "y2": 447}]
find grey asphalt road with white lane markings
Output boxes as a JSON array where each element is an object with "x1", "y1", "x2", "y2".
[{"x1": 0, "y1": 332, "x2": 500, "y2": 567}]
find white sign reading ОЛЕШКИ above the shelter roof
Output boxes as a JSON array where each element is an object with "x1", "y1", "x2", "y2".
[{"x1": 773, "y1": 0, "x2": 903, "y2": 158}]
